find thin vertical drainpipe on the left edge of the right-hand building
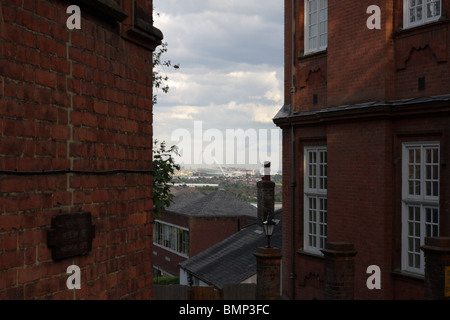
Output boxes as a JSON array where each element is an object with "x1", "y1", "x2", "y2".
[{"x1": 290, "y1": 0, "x2": 296, "y2": 300}]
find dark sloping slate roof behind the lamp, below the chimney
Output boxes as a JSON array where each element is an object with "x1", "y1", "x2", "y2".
[{"x1": 180, "y1": 210, "x2": 282, "y2": 289}]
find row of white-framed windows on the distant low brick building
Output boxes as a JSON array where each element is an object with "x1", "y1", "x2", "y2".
[{"x1": 153, "y1": 220, "x2": 189, "y2": 257}]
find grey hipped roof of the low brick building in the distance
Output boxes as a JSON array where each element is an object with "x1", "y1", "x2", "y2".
[{"x1": 167, "y1": 189, "x2": 257, "y2": 217}]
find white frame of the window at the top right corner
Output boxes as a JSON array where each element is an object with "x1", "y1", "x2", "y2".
[{"x1": 403, "y1": 0, "x2": 442, "y2": 29}]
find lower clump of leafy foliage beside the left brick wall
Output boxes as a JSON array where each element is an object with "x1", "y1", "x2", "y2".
[{"x1": 153, "y1": 140, "x2": 180, "y2": 215}]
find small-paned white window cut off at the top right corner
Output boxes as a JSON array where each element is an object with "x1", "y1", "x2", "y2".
[{"x1": 403, "y1": 0, "x2": 442, "y2": 28}]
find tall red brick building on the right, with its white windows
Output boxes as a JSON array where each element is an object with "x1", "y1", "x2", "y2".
[{"x1": 274, "y1": 0, "x2": 450, "y2": 299}]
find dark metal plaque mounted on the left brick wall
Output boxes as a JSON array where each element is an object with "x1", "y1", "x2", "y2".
[{"x1": 47, "y1": 212, "x2": 95, "y2": 260}]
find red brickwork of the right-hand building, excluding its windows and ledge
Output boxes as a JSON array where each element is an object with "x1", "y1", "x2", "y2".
[{"x1": 275, "y1": 0, "x2": 450, "y2": 299}]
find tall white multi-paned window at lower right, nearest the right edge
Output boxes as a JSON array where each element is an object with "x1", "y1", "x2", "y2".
[{"x1": 402, "y1": 143, "x2": 440, "y2": 274}]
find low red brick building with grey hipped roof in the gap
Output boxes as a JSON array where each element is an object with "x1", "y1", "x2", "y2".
[{"x1": 153, "y1": 188, "x2": 257, "y2": 276}]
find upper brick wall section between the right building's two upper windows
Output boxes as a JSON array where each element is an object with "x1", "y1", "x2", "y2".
[{"x1": 327, "y1": 0, "x2": 393, "y2": 106}]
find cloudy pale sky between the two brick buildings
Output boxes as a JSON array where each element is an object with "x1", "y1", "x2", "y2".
[{"x1": 153, "y1": 0, "x2": 284, "y2": 170}]
